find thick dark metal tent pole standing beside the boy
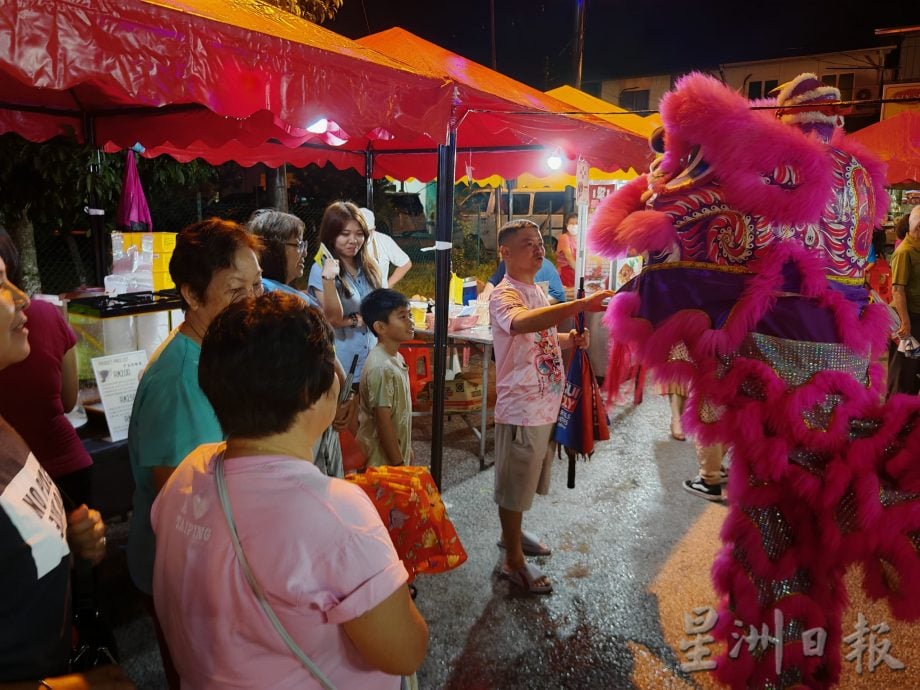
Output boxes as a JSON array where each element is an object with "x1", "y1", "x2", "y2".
[{"x1": 431, "y1": 126, "x2": 457, "y2": 491}]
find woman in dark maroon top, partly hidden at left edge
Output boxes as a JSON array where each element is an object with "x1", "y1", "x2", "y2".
[{"x1": 0, "y1": 230, "x2": 93, "y2": 505}]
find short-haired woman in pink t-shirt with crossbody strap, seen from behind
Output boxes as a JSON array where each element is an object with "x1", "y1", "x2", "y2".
[{"x1": 151, "y1": 292, "x2": 428, "y2": 690}]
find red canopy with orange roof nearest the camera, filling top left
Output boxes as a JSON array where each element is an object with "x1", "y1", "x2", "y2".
[{"x1": 0, "y1": 0, "x2": 451, "y2": 150}]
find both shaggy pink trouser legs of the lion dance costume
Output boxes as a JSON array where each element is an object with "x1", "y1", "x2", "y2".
[{"x1": 689, "y1": 344, "x2": 920, "y2": 689}]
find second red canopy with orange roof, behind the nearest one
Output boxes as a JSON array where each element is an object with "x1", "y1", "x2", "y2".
[{"x1": 135, "y1": 28, "x2": 649, "y2": 181}]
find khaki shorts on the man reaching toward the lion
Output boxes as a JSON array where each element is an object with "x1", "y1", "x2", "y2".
[{"x1": 495, "y1": 424, "x2": 556, "y2": 511}]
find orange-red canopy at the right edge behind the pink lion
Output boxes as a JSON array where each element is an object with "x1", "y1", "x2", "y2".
[{"x1": 850, "y1": 110, "x2": 920, "y2": 188}]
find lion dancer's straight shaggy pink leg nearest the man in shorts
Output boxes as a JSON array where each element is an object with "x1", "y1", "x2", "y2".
[{"x1": 690, "y1": 357, "x2": 871, "y2": 688}]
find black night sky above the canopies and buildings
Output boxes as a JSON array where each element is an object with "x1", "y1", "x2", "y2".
[{"x1": 326, "y1": 0, "x2": 920, "y2": 90}]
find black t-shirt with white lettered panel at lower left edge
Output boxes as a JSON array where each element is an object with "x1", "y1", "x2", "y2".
[{"x1": 0, "y1": 418, "x2": 70, "y2": 682}]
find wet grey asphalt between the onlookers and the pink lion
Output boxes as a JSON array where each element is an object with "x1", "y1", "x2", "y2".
[{"x1": 106, "y1": 384, "x2": 920, "y2": 690}]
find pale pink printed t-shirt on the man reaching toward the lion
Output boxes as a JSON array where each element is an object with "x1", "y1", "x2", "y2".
[{"x1": 489, "y1": 274, "x2": 565, "y2": 426}]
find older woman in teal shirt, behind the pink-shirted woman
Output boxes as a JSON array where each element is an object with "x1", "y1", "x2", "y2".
[{"x1": 128, "y1": 218, "x2": 263, "y2": 688}]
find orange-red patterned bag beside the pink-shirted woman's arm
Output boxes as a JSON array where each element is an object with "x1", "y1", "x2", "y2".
[{"x1": 345, "y1": 466, "x2": 466, "y2": 582}]
